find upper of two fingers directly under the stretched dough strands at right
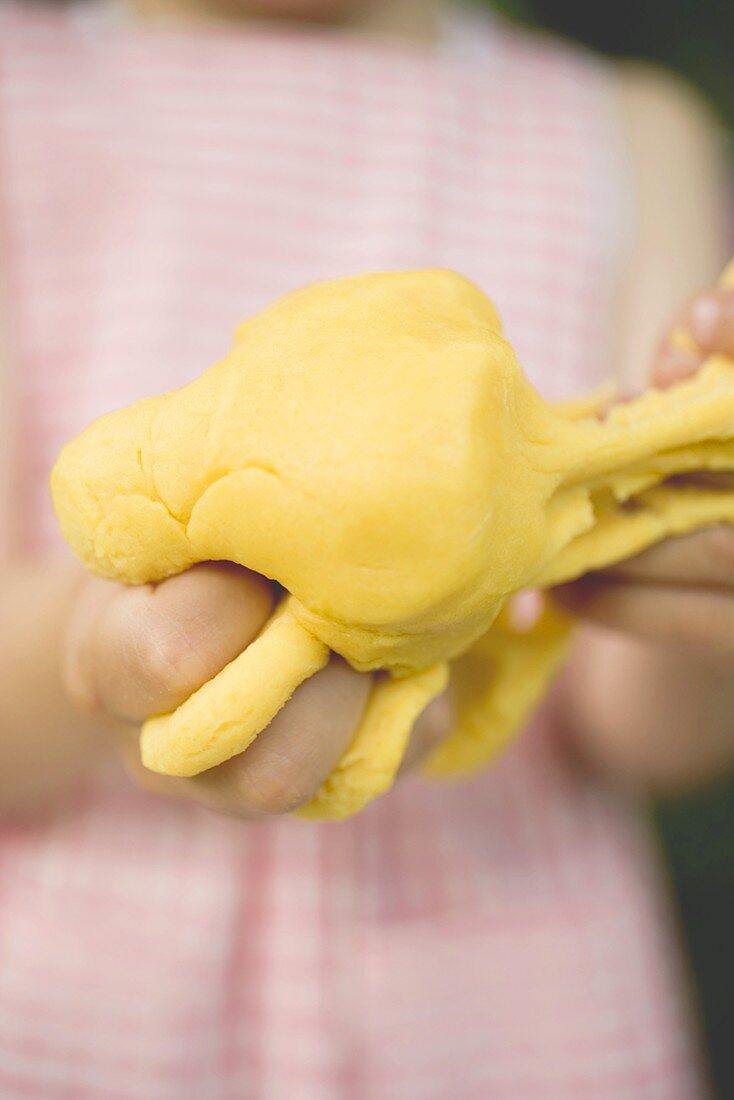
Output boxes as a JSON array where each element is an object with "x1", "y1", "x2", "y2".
[{"x1": 589, "y1": 524, "x2": 734, "y2": 594}]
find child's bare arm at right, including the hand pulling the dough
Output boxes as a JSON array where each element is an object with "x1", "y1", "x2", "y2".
[{"x1": 559, "y1": 64, "x2": 734, "y2": 791}]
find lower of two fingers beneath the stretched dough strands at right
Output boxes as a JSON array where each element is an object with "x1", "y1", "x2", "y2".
[{"x1": 554, "y1": 576, "x2": 734, "y2": 659}]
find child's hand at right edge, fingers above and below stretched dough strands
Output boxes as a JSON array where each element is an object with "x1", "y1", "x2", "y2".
[{"x1": 557, "y1": 289, "x2": 734, "y2": 660}]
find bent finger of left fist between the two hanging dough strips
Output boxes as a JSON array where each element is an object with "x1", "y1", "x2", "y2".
[{"x1": 182, "y1": 659, "x2": 372, "y2": 818}]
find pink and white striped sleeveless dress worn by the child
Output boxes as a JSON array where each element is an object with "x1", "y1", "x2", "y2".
[{"x1": 0, "y1": 6, "x2": 702, "y2": 1100}]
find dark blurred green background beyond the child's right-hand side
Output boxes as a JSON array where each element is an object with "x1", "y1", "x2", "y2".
[{"x1": 481, "y1": 0, "x2": 734, "y2": 1100}]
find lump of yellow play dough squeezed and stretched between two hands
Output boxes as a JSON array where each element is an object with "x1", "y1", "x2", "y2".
[{"x1": 52, "y1": 264, "x2": 734, "y2": 817}]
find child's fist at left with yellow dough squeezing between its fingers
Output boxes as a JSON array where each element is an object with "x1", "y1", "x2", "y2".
[{"x1": 64, "y1": 562, "x2": 450, "y2": 818}]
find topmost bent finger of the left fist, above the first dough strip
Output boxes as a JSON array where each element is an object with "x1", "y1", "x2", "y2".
[{"x1": 69, "y1": 562, "x2": 274, "y2": 722}]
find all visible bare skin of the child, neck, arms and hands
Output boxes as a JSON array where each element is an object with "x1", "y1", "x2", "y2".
[{"x1": 0, "y1": 0, "x2": 734, "y2": 820}]
